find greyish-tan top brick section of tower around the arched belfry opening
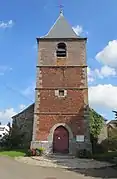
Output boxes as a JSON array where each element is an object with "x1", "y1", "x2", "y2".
[{"x1": 38, "y1": 39, "x2": 86, "y2": 66}]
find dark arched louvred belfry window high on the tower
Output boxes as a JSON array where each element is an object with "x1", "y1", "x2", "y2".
[{"x1": 56, "y1": 43, "x2": 67, "y2": 57}]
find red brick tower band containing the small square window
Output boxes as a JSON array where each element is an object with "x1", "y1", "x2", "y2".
[{"x1": 38, "y1": 90, "x2": 87, "y2": 113}]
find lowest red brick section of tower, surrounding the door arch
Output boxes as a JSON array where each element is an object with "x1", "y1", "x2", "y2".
[{"x1": 36, "y1": 115, "x2": 84, "y2": 141}]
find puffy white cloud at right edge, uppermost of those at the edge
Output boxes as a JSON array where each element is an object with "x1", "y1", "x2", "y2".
[{"x1": 96, "y1": 40, "x2": 117, "y2": 67}]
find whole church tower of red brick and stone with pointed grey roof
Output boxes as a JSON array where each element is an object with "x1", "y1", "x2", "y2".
[{"x1": 31, "y1": 13, "x2": 91, "y2": 154}]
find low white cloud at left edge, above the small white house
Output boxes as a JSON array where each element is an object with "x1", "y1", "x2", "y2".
[{"x1": 0, "y1": 108, "x2": 16, "y2": 123}]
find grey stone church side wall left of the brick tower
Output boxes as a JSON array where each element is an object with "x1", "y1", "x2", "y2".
[{"x1": 12, "y1": 104, "x2": 34, "y2": 147}]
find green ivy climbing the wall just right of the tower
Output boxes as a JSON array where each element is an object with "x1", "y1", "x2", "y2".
[{"x1": 89, "y1": 109, "x2": 104, "y2": 138}]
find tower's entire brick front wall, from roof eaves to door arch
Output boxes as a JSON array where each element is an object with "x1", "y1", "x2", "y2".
[{"x1": 33, "y1": 39, "x2": 88, "y2": 144}]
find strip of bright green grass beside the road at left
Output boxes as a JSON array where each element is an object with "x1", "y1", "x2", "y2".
[{"x1": 0, "y1": 150, "x2": 25, "y2": 157}]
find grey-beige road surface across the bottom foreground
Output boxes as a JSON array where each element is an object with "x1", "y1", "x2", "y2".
[{"x1": 0, "y1": 157, "x2": 117, "y2": 179}]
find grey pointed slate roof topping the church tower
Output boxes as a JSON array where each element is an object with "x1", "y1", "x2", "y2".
[{"x1": 41, "y1": 12, "x2": 78, "y2": 39}]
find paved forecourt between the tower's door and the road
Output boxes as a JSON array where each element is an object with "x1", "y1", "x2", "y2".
[{"x1": 16, "y1": 156, "x2": 113, "y2": 169}]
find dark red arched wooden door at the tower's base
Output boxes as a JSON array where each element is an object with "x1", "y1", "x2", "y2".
[{"x1": 53, "y1": 126, "x2": 69, "y2": 153}]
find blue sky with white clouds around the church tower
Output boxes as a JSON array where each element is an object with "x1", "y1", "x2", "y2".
[{"x1": 0, "y1": 0, "x2": 117, "y2": 123}]
